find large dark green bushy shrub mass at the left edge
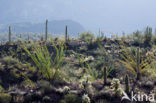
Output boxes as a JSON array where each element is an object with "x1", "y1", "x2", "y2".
[{"x1": 0, "y1": 56, "x2": 36, "y2": 87}]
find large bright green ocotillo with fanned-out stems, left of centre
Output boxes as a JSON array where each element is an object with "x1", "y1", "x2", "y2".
[{"x1": 24, "y1": 43, "x2": 64, "y2": 81}]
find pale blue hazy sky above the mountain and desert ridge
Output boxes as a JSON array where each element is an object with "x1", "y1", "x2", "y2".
[{"x1": 0, "y1": 0, "x2": 156, "y2": 33}]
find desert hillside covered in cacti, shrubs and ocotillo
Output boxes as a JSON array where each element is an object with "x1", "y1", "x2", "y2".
[{"x1": 0, "y1": 23, "x2": 156, "y2": 103}]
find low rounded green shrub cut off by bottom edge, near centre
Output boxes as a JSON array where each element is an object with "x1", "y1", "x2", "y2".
[{"x1": 60, "y1": 94, "x2": 82, "y2": 103}]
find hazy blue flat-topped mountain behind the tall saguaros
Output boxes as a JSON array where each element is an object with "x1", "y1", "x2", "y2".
[{"x1": 0, "y1": 20, "x2": 85, "y2": 35}]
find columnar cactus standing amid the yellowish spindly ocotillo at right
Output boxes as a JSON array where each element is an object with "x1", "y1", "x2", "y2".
[{"x1": 136, "y1": 48, "x2": 141, "y2": 80}]
